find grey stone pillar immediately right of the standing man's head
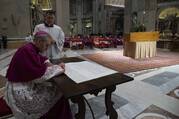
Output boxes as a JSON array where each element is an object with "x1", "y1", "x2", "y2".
[{"x1": 56, "y1": 0, "x2": 70, "y2": 35}]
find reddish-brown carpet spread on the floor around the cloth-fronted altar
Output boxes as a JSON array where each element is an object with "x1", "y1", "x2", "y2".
[{"x1": 83, "y1": 51, "x2": 179, "y2": 73}]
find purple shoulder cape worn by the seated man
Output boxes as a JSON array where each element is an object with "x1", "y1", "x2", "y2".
[{"x1": 6, "y1": 45, "x2": 47, "y2": 82}]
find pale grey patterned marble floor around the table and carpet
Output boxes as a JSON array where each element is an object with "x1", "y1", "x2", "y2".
[{"x1": 0, "y1": 47, "x2": 179, "y2": 119}]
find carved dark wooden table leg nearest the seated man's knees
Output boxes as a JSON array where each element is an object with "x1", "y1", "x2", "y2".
[{"x1": 71, "y1": 96, "x2": 86, "y2": 119}]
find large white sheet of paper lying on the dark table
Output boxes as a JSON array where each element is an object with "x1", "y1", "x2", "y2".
[{"x1": 65, "y1": 61, "x2": 117, "y2": 83}]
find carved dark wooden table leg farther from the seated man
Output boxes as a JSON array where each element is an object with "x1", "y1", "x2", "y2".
[{"x1": 105, "y1": 86, "x2": 118, "y2": 119}]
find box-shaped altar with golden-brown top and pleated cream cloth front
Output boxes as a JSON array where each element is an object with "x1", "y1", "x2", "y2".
[{"x1": 124, "y1": 32, "x2": 159, "y2": 59}]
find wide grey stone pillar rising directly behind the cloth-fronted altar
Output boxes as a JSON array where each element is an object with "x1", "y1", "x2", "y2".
[{"x1": 124, "y1": 0, "x2": 157, "y2": 33}]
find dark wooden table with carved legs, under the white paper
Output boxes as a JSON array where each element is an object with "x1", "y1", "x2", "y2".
[{"x1": 53, "y1": 57, "x2": 133, "y2": 119}]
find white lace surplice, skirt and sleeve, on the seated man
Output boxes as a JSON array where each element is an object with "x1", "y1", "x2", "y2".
[{"x1": 5, "y1": 65, "x2": 62, "y2": 119}]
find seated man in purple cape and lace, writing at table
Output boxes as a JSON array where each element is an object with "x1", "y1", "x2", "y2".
[{"x1": 5, "y1": 31, "x2": 72, "y2": 119}]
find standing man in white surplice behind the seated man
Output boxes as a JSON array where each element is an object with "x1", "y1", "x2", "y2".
[{"x1": 34, "y1": 11, "x2": 65, "y2": 60}]
